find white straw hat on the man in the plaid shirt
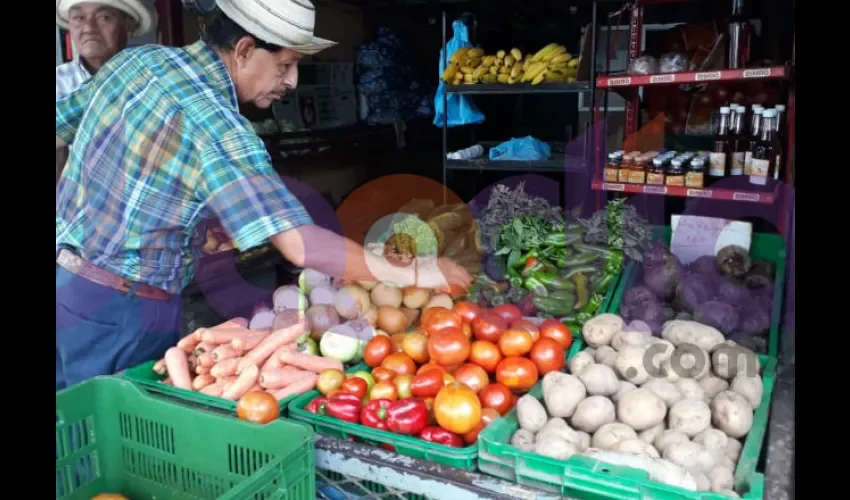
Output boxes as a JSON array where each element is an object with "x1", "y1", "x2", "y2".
[{"x1": 216, "y1": 0, "x2": 336, "y2": 55}]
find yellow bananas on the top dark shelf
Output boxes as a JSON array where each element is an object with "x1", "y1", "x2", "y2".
[{"x1": 442, "y1": 43, "x2": 579, "y2": 85}]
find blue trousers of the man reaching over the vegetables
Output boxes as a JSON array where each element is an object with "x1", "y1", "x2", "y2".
[{"x1": 56, "y1": 264, "x2": 180, "y2": 391}]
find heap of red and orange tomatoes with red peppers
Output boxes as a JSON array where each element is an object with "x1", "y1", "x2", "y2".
[{"x1": 307, "y1": 301, "x2": 572, "y2": 447}]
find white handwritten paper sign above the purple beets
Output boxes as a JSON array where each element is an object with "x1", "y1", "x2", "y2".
[{"x1": 670, "y1": 215, "x2": 753, "y2": 265}]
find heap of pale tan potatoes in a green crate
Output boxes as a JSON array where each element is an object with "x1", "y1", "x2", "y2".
[{"x1": 511, "y1": 314, "x2": 763, "y2": 498}]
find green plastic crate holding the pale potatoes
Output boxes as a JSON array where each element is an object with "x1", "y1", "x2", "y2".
[{"x1": 478, "y1": 335, "x2": 776, "y2": 500}]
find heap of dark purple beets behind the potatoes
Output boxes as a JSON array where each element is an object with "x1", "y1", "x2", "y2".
[{"x1": 620, "y1": 242, "x2": 776, "y2": 353}]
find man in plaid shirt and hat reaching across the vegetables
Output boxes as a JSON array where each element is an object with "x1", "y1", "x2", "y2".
[{"x1": 56, "y1": 0, "x2": 471, "y2": 390}]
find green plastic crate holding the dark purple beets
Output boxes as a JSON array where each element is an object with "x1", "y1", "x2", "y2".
[{"x1": 605, "y1": 226, "x2": 786, "y2": 357}]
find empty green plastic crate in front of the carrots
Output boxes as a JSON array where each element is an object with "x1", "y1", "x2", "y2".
[{"x1": 56, "y1": 377, "x2": 316, "y2": 500}]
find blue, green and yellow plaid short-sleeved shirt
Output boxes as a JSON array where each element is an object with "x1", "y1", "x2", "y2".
[{"x1": 56, "y1": 41, "x2": 312, "y2": 293}]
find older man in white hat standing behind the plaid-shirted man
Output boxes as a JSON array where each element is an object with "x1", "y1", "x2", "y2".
[{"x1": 56, "y1": 0, "x2": 156, "y2": 183}]
